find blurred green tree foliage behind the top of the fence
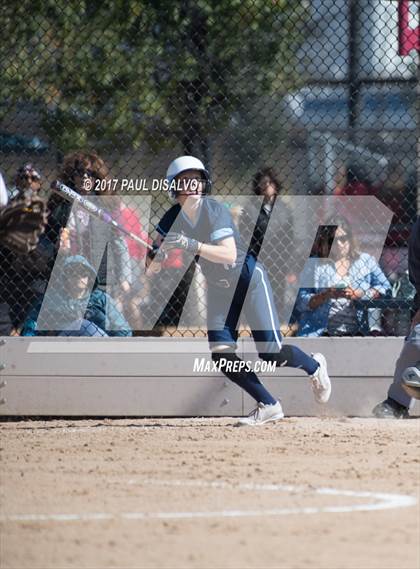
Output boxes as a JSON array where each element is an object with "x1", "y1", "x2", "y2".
[{"x1": 0, "y1": 0, "x2": 305, "y2": 152}]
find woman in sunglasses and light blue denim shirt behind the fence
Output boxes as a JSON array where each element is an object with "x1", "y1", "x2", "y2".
[{"x1": 296, "y1": 219, "x2": 390, "y2": 336}]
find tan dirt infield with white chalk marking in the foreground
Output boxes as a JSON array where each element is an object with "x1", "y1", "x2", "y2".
[{"x1": 0, "y1": 418, "x2": 420, "y2": 569}]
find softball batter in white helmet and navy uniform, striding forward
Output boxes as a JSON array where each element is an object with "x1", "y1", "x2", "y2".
[{"x1": 148, "y1": 156, "x2": 331, "y2": 425}]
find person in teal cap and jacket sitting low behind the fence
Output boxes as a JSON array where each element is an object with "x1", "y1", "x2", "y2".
[{"x1": 21, "y1": 255, "x2": 131, "y2": 336}]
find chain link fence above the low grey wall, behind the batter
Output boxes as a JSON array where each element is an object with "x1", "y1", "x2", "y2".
[{"x1": 0, "y1": 0, "x2": 420, "y2": 336}]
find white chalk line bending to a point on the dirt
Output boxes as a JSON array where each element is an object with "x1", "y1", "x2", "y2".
[{"x1": 0, "y1": 479, "x2": 417, "y2": 523}]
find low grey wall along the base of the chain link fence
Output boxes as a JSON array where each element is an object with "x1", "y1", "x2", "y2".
[{"x1": 0, "y1": 337, "x2": 420, "y2": 417}]
